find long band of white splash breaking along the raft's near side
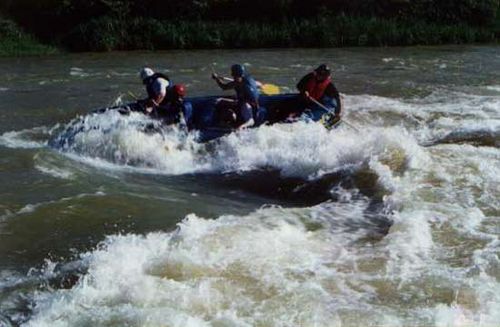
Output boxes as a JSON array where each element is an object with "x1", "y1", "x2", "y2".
[{"x1": 53, "y1": 112, "x2": 425, "y2": 184}]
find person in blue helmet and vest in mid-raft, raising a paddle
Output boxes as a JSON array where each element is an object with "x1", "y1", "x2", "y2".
[{"x1": 212, "y1": 64, "x2": 260, "y2": 129}]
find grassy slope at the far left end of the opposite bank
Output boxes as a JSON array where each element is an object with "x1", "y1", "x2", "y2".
[{"x1": 0, "y1": 17, "x2": 59, "y2": 56}]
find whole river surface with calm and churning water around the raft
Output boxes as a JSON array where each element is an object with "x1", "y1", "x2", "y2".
[{"x1": 0, "y1": 46, "x2": 500, "y2": 326}]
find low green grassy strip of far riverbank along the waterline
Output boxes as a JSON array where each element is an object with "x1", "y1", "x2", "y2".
[{"x1": 0, "y1": 16, "x2": 500, "y2": 56}]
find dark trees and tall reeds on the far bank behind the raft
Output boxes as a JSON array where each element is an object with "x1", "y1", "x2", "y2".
[{"x1": 0, "y1": 0, "x2": 500, "y2": 51}]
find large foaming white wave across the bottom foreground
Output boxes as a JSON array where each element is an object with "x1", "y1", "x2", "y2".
[{"x1": 22, "y1": 186, "x2": 500, "y2": 326}]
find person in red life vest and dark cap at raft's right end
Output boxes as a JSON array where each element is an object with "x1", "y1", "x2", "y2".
[{"x1": 289, "y1": 64, "x2": 342, "y2": 120}]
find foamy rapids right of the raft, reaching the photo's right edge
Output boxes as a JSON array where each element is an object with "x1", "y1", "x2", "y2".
[{"x1": 345, "y1": 90, "x2": 500, "y2": 144}]
